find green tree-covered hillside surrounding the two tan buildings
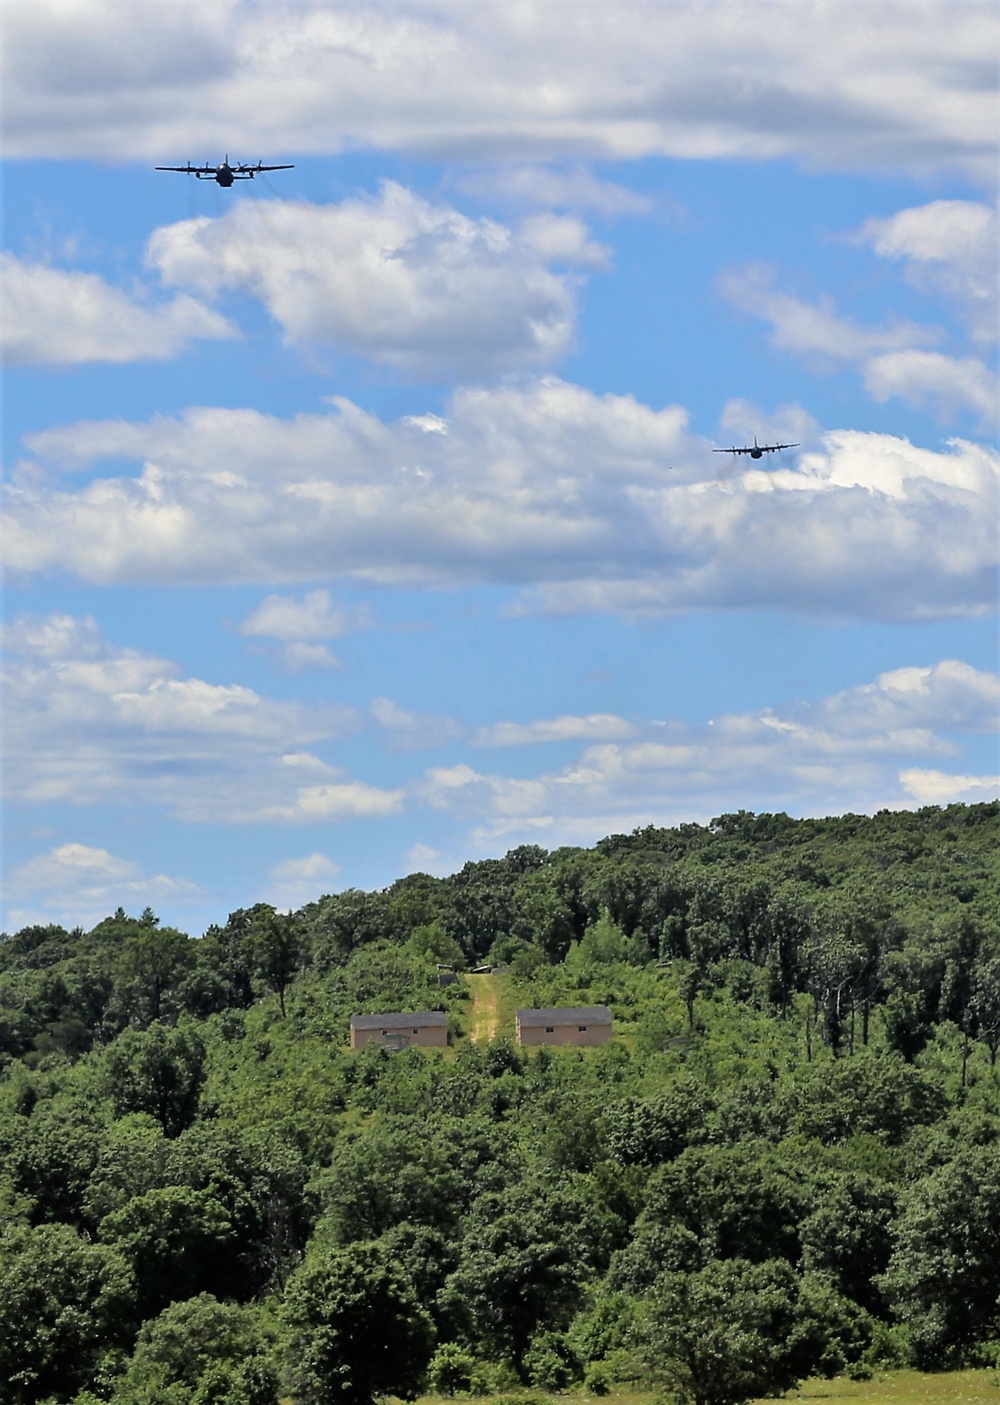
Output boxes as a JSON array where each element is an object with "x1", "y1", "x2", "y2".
[{"x1": 0, "y1": 804, "x2": 1000, "y2": 1405}]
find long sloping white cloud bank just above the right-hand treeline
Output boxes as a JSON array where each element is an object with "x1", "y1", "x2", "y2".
[{"x1": 419, "y1": 660, "x2": 1000, "y2": 851}]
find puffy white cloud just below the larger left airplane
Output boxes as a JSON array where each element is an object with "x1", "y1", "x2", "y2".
[{"x1": 147, "y1": 189, "x2": 603, "y2": 377}]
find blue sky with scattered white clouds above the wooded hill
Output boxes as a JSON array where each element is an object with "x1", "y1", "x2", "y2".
[{"x1": 4, "y1": 0, "x2": 1000, "y2": 932}]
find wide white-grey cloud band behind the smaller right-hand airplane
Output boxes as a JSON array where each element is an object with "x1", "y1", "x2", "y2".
[{"x1": 4, "y1": 378, "x2": 1000, "y2": 618}]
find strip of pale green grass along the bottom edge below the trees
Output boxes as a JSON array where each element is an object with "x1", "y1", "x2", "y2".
[{"x1": 417, "y1": 1371, "x2": 1000, "y2": 1405}]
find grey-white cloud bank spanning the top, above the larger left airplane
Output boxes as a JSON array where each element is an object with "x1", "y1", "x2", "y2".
[{"x1": 4, "y1": 0, "x2": 996, "y2": 183}]
